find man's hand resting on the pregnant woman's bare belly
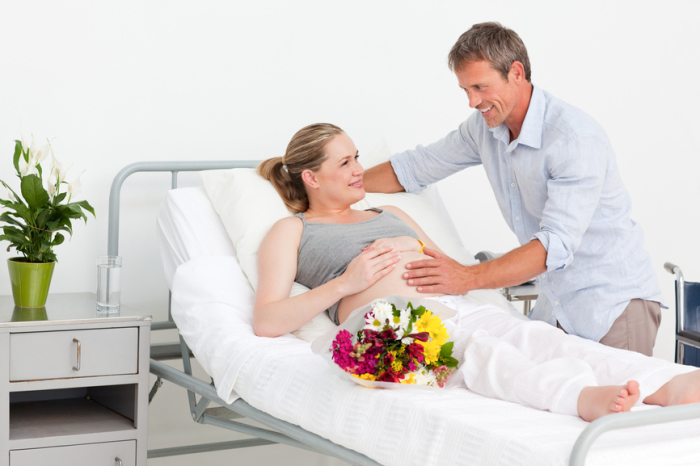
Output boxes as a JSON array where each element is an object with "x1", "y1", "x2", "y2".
[{"x1": 402, "y1": 248, "x2": 477, "y2": 295}]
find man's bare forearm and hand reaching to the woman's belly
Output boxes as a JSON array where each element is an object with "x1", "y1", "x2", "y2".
[{"x1": 403, "y1": 239, "x2": 547, "y2": 295}]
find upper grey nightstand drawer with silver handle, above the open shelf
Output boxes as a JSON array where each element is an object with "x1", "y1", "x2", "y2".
[{"x1": 10, "y1": 327, "x2": 139, "y2": 381}]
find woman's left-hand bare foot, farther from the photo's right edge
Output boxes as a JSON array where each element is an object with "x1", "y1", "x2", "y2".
[{"x1": 576, "y1": 380, "x2": 639, "y2": 422}]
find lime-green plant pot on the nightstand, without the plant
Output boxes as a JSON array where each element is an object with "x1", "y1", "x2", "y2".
[{"x1": 7, "y1": 257, "x2": 56, "y2": 307}]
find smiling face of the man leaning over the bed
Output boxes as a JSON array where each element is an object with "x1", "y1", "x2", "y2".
[{"x1": 455, "y1": 60, "x2": 518, "y2": 128}]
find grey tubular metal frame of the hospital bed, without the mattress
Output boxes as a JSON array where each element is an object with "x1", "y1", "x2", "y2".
[{"x1": 107, "y1": 160, "x2": 700, "y2": 466}]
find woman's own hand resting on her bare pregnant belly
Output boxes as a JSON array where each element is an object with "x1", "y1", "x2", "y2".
[{"x1": 338, "y1": 244, "x2": 404, "y2": 296}]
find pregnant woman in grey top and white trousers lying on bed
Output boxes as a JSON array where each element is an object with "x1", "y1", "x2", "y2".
[{"x1": 254, "y1": 123, "x2": 700, "y2": 421}]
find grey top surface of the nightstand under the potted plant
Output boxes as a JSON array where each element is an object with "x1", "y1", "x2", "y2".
[{"x1": 0, "y1": 293, "x2": 151, "y2": 328}]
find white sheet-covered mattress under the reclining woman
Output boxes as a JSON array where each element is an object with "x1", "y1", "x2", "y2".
[{"x1": 162, "y1": 187, "x2": 700, "y2": 466}]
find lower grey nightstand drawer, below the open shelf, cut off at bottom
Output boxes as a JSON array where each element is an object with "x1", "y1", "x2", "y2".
[{"x1": 10, "y1": 440, "x2": 136, "y2": 466}]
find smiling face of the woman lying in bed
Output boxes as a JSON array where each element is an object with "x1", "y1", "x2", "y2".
[{"x1": 309, "y1": 133, "x2": 365, "y2": 205}]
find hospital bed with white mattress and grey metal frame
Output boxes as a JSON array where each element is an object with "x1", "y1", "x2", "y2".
[{"x1": 108, "y1": 161, "x2": 700, "y2": 465}]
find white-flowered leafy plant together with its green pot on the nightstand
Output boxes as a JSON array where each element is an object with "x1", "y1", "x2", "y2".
[{"x1": 0, "y1": 136, "x2": 95, "y2": 307}]
